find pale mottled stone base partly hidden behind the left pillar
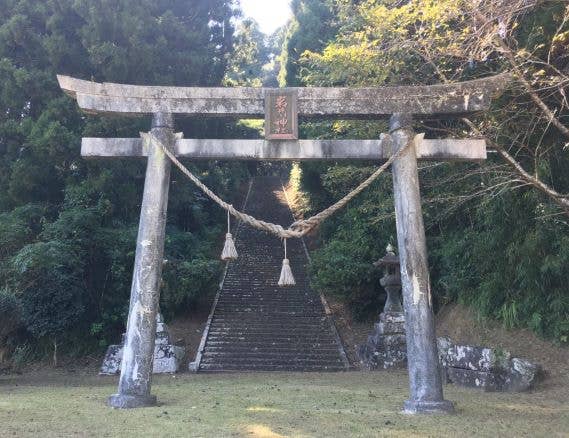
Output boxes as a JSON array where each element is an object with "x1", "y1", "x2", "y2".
[{"x1": 99, "y1": 315, "x2": 185, "y2": 374}]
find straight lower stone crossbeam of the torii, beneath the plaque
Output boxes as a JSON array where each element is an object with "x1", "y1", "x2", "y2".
[{"x1": 81, "y1": 136, "x2": 486, "y2": 161}]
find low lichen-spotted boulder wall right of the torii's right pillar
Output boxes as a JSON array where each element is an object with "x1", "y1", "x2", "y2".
[{"x1": 437, "y1": 338, "x2": 543, "y2": 391}]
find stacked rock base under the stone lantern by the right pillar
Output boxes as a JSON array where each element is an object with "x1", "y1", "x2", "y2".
[{"x1": 357, "y1": 312, "x2": 407, "y2": 370}]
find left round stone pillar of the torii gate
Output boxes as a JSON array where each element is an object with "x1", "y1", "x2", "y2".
[{"x1": 108, "y1": 113, "x2": 175, "y2": 409}]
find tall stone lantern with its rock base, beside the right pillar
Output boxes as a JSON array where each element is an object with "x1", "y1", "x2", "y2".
[{"x1": 357, "y1": 245, "x2": 407, "y2": 370}]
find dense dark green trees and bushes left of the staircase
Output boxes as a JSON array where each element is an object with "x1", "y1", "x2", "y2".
[{"x1": 0, "y1": 0, "x2": 247, "y2": 362}]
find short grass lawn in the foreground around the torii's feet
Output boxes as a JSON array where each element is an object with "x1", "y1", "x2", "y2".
[{"x1": 0, "y1": 371, "x2": 569, "y2": 437}]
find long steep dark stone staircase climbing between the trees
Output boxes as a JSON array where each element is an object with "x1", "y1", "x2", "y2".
[{"x1": 190, "y1": 177, "x2": 349, "y2": 372}]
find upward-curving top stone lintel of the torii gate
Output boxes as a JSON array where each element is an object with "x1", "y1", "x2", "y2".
[{"x1": 57, "y1": 73, "x2": 511, "y2": 119}]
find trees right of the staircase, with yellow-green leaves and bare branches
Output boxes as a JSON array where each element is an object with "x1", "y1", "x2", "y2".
[{"x1": 286, "y1": 0, "x2": 569, "y2": 342}]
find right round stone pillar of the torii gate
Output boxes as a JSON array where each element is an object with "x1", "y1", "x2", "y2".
[{"x1": 390, "y1": 114, "x2": 454, "y2": 414}]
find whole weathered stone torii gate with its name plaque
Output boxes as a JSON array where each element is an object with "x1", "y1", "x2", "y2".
[{"x1": 58, "y1": 75, "x2": 509, "y2": 413}]
